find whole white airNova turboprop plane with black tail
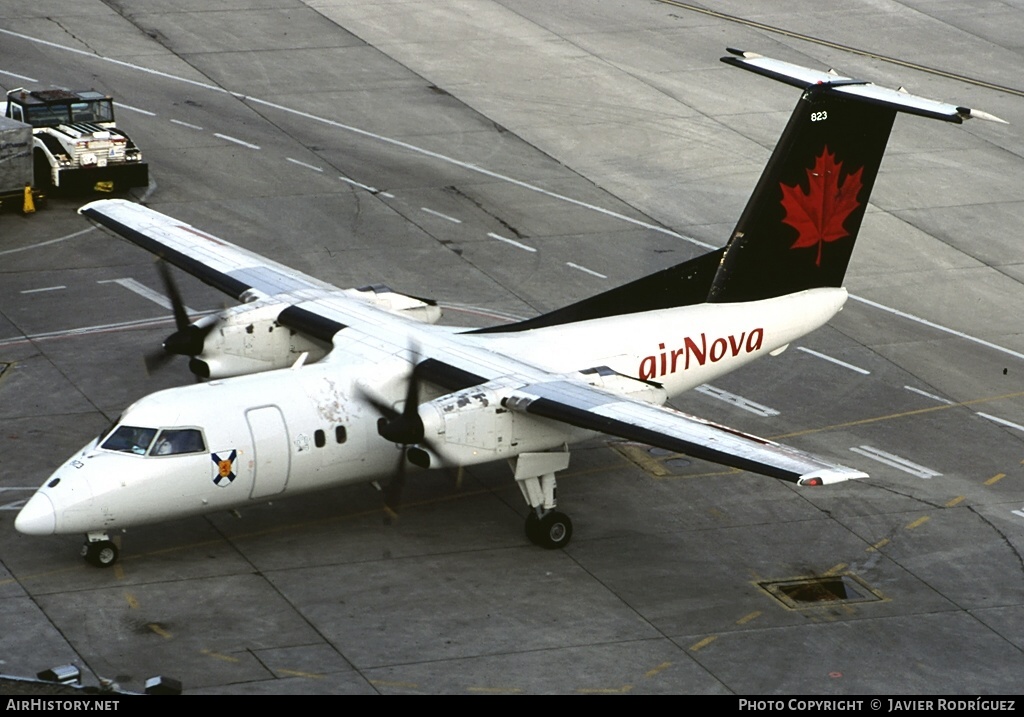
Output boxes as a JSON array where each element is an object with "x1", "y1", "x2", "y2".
[{"x1": 15, "y1": 50, "x2": 1001, "y2": 565}]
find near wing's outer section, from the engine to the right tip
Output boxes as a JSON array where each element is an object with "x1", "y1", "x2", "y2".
[{"x1": 504, "y1": 380, "x2": 867, "y2": 486}]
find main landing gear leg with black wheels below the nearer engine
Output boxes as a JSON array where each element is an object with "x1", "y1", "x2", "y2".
[{"x1": 509, "y1": 451, "x2": 572, "y2": 550}]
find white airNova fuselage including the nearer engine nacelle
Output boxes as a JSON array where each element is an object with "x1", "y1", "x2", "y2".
[{"x1": 15, "y1": 289, "x2": 846, "y2": 535}]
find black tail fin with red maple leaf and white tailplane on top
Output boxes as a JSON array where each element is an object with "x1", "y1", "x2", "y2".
[{"x1": 708, "y1": 50, "x2": 992, "y2": 302}]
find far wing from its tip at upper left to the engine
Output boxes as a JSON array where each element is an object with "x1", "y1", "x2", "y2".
[{"x1": 78, "y1": 199, "x2": 338, "y2": 301}]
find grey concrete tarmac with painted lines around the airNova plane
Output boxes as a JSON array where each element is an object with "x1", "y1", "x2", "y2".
[{"x1": 0, "y1": 0, "x2": 1024, "y2": 695}]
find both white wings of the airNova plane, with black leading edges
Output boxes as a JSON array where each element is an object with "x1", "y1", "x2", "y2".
[{"x1": 79, "y1": 200, "x2": 866, "y2": 484}]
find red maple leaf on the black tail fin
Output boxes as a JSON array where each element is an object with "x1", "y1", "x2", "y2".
[{"x1": 779, "y1": 145, "x2": 864, "y2": 266}]
